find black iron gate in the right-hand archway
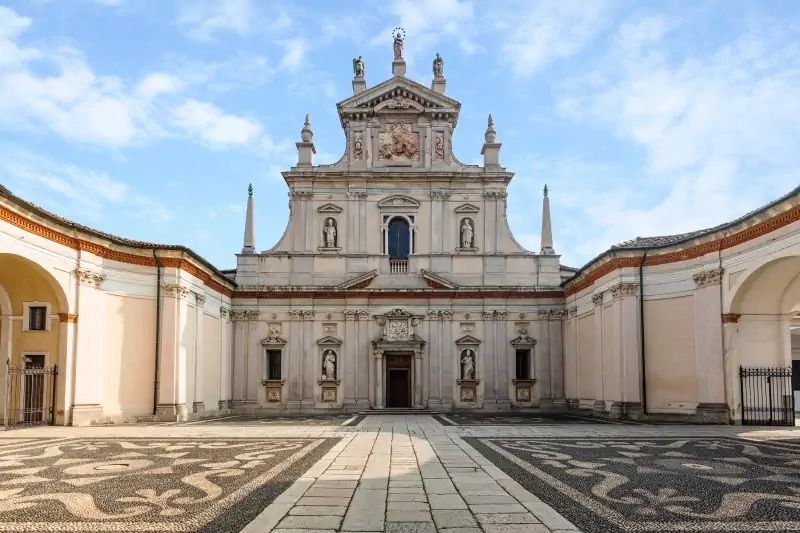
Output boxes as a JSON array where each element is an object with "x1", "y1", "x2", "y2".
[{"x1": 739, "y1": 366, "x2": 794, "y2": 426}]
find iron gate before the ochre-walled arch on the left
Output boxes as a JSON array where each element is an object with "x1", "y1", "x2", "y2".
[{"x1": 5, "y1": 362, "x2": 57, "y2": 428}]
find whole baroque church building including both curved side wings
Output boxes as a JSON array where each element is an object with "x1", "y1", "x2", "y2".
[{"x1": 0, "y1": 35, "x2": 800, "y2": 425}]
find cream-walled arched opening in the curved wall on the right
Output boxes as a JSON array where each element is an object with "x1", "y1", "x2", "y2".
[{"x1": 725, "y1": 255, "x2": 800, "y2": 424}]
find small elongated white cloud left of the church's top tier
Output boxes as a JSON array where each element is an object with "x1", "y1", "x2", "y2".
[{"x1": 172, "y1": 100, "x2": 261, "y2": 148}]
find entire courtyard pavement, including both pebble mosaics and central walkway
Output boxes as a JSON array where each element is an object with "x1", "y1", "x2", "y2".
[{"x1": 0, "y1": 415, "x2": 800, "y2": 533}]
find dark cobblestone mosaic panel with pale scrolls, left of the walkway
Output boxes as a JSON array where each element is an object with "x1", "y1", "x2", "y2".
[{"x1": 0, "y1": 438, "x2": 338, "y2": 533}]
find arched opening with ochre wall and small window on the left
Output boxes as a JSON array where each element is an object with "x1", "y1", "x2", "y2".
[{"x1": 0, "y1": 254, "x2": 68, "y2": 424}]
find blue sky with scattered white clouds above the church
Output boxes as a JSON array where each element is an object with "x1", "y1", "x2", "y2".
[{"x1": 0, "y1": 0, "x2": 800, "y2": 268}]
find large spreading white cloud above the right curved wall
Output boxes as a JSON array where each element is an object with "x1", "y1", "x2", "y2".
[{"x1": 553, "y1": 17, "x2": 800, "y2": 259}]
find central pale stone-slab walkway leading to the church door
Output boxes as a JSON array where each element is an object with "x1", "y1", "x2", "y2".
[{"x1": 243, "y1": 416, "x2": 579, "y2": 533}]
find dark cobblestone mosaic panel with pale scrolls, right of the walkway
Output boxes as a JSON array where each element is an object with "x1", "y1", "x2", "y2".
[{"x1": 464, "y1": 438, "x2": 800, "y2": 533}]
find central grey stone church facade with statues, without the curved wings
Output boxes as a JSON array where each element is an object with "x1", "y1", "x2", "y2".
[{"x1": 233, "y1": 40, "x2": 564, "y2": 411}]
